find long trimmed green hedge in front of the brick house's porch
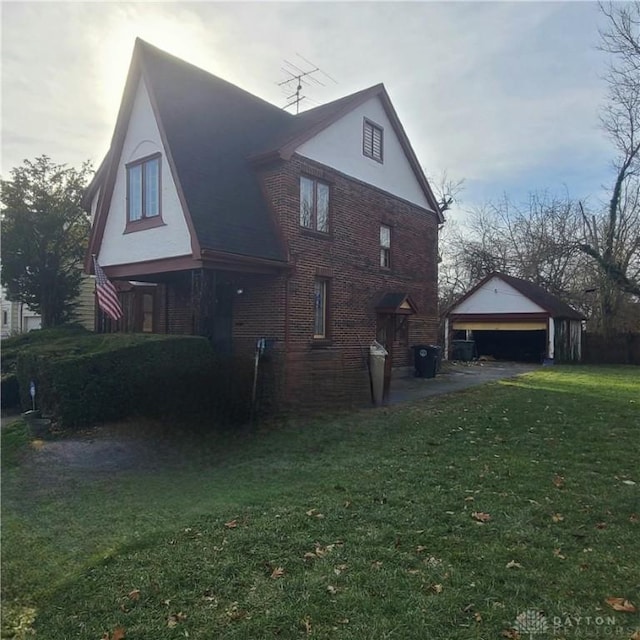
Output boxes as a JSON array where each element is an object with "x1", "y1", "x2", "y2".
[{"x1": 17, "y1": 336, "x2": 264, "y2": 427}]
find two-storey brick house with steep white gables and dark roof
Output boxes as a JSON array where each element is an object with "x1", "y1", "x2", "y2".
[{"x1": 85, "y1": 40, "x2": 443, "y2": 404}]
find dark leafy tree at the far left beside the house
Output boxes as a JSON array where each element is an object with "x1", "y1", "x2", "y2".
[{"x1": 0, "y1": 155, "x2": 92, "y2": 328}]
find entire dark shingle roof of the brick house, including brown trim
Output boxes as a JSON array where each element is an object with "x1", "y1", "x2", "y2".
[{"x1": 86, "y1": 39, "x2": 441, "y2": 262}]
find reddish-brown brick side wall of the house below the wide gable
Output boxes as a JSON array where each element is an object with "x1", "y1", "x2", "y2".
[{"x1": 255, "y1": 156, "x2": 438, "y2": 405}]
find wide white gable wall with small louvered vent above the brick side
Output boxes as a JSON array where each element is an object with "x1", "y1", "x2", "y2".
[{"x1": 296, "y1": 97, "x2": 431, "y2": 210}]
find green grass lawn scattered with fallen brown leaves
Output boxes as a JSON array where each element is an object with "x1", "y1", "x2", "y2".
[{"x1": 2, "y1": 367, "x2": 640, "y2": 640}]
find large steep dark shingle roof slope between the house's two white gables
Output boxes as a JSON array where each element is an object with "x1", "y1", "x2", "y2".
[{"x1": 137, "y1": 41, "x2": 293, "y2": 260}]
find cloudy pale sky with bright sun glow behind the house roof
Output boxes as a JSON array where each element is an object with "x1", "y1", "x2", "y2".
[{"x1": 1, "y1": 2, "x2": 612, "y2": 218}]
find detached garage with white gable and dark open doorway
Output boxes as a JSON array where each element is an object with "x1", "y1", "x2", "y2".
[{"x1": 445, "y1": 273, "x2": 585, "y2": 362}]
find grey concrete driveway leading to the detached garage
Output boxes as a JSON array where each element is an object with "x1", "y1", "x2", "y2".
[{"x1": 388, "y1": 362, "x2": 541, "y2": 404}]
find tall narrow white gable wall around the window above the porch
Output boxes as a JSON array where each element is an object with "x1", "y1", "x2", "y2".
[{"x1": 99, "y1": 80, "x2": 191, "y2": 266}]
